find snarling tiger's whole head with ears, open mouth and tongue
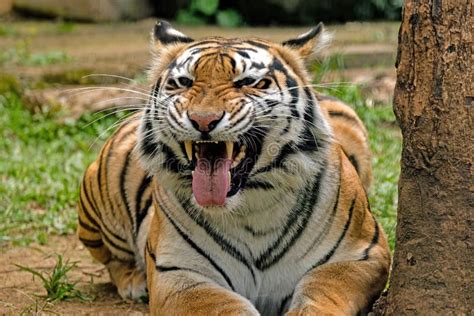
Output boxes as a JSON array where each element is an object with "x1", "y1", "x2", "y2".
[{"x1": 137, "y1": 22, "x2": 331, "y2": 210}]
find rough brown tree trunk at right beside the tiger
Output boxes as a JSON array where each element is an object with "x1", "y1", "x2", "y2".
[{"x1": 376, "y1": 0, "x2": 474, "y2": 315}]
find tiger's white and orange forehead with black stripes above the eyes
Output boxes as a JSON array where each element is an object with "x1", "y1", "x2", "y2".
[{"x1": 170, "y1": 39, "x2": 273, "y2": 80}]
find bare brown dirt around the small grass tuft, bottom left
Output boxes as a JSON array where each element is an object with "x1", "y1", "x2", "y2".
[{"x1": 0, "y1": 236, "x2": 148, "y2": 315}]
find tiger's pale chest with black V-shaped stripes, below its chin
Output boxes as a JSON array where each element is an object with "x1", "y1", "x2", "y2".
[{"x1": 157, "y1": 201, "x2": 332, "y2": 315}]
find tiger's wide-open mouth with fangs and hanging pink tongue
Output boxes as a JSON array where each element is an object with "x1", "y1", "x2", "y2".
[{"x1": 184, "y1": 141, "x2": 252, "y2": 206}]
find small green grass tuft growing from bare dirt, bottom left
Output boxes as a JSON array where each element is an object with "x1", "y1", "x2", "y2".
[{"x1": 16, "y1": 255, "x2": 90, "y2": 303}]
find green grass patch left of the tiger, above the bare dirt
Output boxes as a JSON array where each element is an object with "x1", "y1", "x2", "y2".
[{"x1": 0, "y1": 93, "x2": 127, "y2": 245}]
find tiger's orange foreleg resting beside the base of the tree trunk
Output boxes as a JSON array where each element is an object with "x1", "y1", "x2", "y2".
[{"x1": 286, "y1": 241, "x2": 389, "y2": 316}]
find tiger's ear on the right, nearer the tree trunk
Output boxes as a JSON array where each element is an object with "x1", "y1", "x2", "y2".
[{"x1": 282, "y1": 22, "x2": 332, "y2": 61}]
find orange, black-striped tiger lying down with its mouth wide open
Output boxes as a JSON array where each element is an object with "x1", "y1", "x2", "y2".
[{"x1": 78, "y1": 21, "x2": 391, "y2": 315}]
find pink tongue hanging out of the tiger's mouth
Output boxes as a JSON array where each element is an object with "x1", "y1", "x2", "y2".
[{"x1": 193, "y1": 158, "x2": 232, "y2": 206}]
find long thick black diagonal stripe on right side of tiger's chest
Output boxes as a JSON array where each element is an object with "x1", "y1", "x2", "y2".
[{"x1": 255, "y1": 166, "x2": 326, "y2": 270}]
